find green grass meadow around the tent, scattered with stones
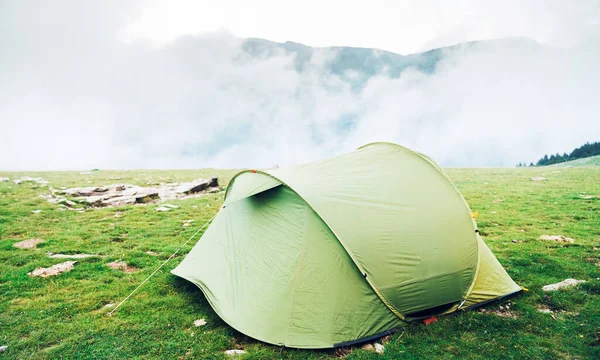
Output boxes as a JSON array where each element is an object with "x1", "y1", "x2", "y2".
[{"x1": 0, "y1": 167, "x2": 600, "y2": 359}]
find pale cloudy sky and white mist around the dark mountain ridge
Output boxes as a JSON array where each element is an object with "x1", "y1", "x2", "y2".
[{"x1": 0, "y1": 0, "x2": 600, "y2": 170}]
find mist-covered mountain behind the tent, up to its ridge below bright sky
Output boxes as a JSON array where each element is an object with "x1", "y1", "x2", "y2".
[{"x1": 0, "y1": 9, "x2": 600, "y2": 170}]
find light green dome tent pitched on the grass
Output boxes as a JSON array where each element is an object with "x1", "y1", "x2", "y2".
[{"x1": 172, "y1": 143, "x2": 521, "y2": 348}]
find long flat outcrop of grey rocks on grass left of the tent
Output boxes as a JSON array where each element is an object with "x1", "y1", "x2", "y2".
[{"x1": 42, "y1": 177, "x2": 224, "y2": 208}]
